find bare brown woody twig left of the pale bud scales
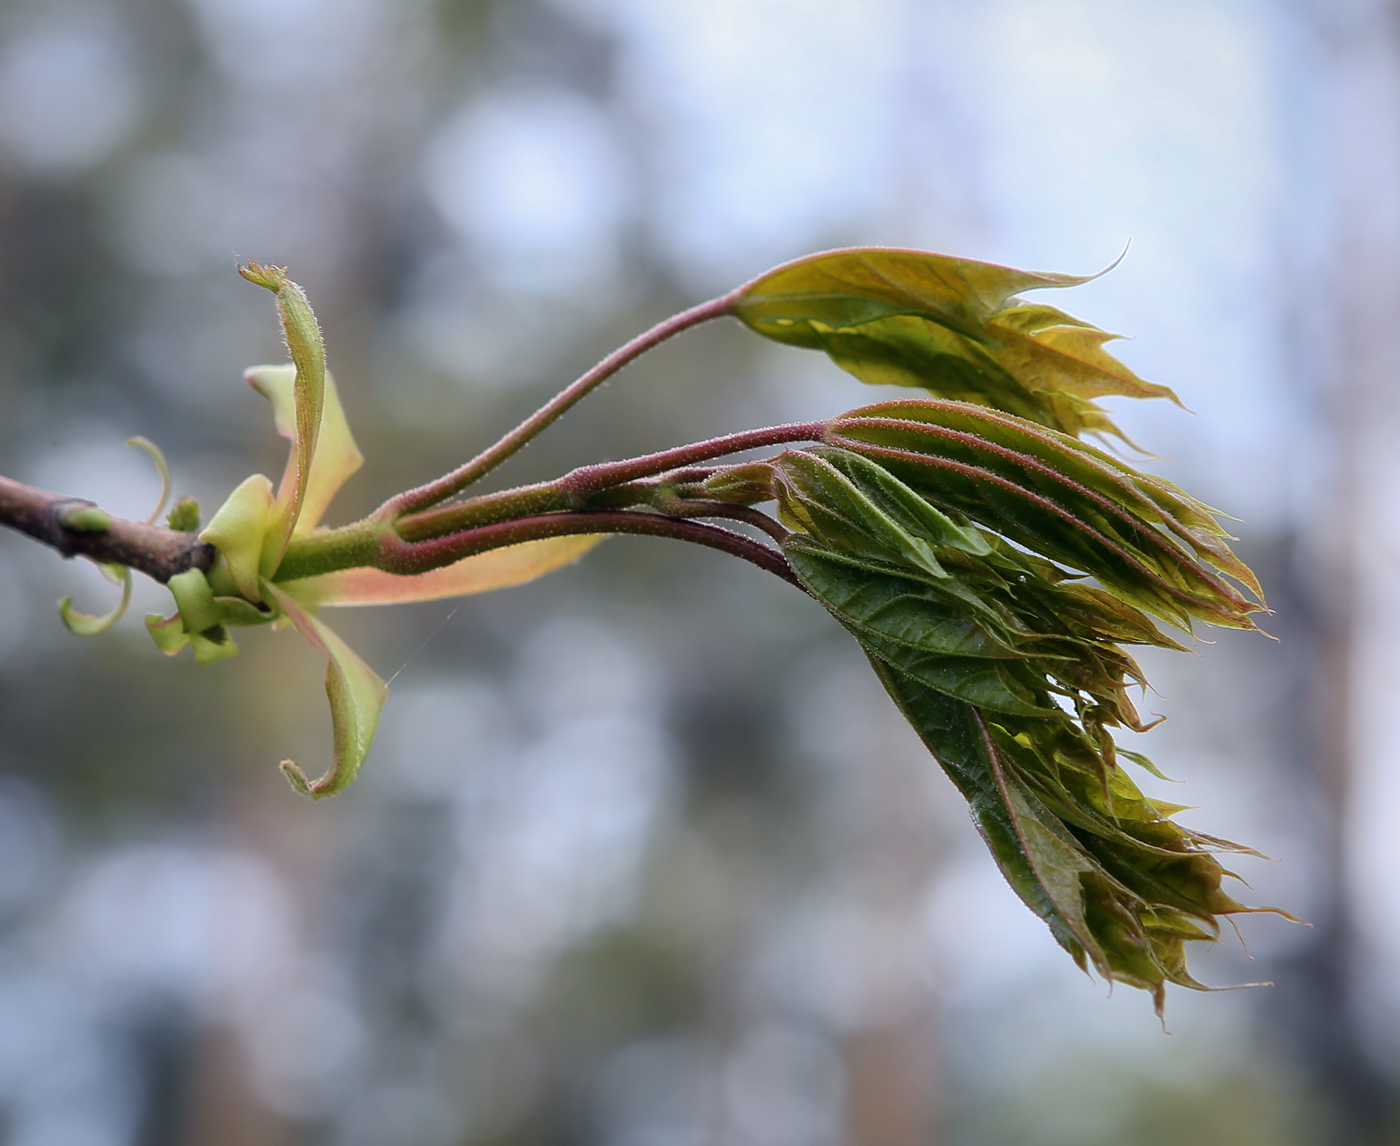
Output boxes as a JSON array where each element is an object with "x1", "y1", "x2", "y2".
[{"x1": 0, "y1": 477, "x2": 218, "y2": 583}]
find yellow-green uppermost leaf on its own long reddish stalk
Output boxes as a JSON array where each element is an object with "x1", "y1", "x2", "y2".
[{"x1": 732, "y1": 248, "x2": 1175, "y2": 437}]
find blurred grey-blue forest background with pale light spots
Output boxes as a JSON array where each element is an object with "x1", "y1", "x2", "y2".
[{"x1": 0, "y1": 0, "x2": 1383, "y2": 1146}]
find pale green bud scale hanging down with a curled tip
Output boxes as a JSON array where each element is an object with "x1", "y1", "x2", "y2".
[{"x1": 263, "y1": 581, "x2": 389, "y2": 799}]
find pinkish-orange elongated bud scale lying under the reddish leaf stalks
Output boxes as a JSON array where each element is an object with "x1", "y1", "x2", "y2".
[{"x1": 281, "y1": 533, "x2": 606, "y2": 607}]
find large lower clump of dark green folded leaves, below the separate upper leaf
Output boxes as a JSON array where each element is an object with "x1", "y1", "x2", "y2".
[{"x1": 706, "y1": 402, "x2": 1282, "y2": 1010}]
